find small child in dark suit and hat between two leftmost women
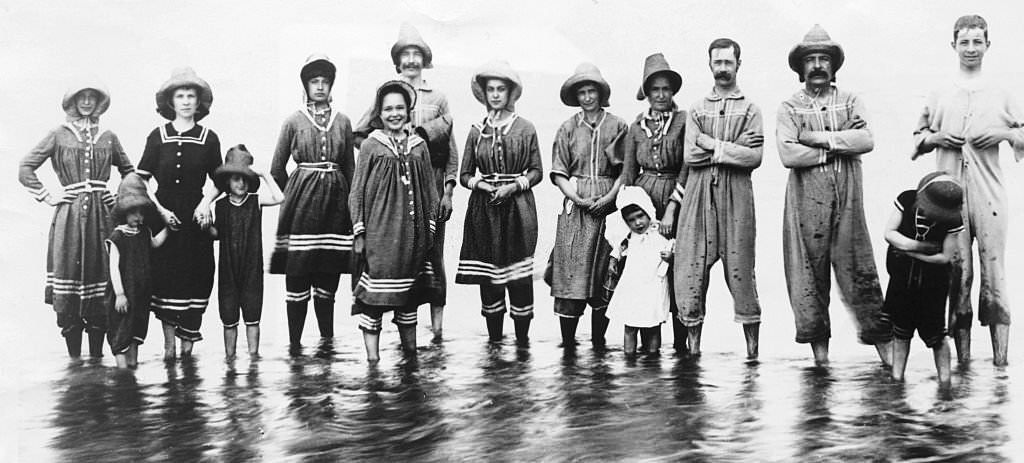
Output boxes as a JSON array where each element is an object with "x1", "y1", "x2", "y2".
[{"x1": 105, "y1": 173, "x2": 169, "y2": 368}]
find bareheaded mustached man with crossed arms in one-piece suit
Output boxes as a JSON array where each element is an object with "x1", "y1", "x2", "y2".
[{"x1": 675, "y1": 39, "x2": 764, "y2": 360}]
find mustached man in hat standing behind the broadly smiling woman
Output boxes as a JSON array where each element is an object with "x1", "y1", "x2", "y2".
[{"x1": 355, "y1": 24, "x2": 459, "y2": 341}]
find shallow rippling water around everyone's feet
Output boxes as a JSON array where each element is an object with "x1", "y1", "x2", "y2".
[{"x1": 6, "y1": 287, "x2": 1024, "y2": 462}]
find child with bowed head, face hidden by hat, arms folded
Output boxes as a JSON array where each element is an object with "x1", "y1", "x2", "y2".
[{"x1": 883, "y1": 171, "x2": 964, "y2": 385}]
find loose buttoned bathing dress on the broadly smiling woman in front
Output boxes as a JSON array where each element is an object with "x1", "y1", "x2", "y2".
[{"x1": 349, "y1": 130, "x2": 441, "y2": 319}]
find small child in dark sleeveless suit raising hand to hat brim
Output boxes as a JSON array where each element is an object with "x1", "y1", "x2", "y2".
[{"x1": 210, "y1": 144, "x2": 285, "y2": 359}]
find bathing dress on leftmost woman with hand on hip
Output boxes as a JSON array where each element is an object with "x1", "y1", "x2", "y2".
[{"x1": 18, "y1": 123, "x2": 134, "y2": 335}]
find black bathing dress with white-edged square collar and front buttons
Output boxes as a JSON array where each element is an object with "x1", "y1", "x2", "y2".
[{"x1": 138, "y1": 123, "x2": 223, "y2": 342}]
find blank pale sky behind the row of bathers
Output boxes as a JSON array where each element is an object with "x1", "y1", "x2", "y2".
[{"x1": 0, "y1": 0, "x2": 1024, "y2": 354}]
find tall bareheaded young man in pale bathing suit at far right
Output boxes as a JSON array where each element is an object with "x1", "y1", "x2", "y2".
[{"x1": 913, "y1": 14, "x2": 1024, "y2": 366}]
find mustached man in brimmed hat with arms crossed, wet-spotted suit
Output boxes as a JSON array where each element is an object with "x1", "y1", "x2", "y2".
[{"x1": 776, "y1": 25, "x2": 892, "y2": 365}]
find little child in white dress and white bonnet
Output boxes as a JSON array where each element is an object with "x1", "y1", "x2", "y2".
[{"x1": 605, "y1": 186, "x2": 674, "y2": 355}]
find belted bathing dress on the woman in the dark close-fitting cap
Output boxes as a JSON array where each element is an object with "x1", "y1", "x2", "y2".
[{"x1": 270, "y1": 109, "x2": 355, "y2": 277}]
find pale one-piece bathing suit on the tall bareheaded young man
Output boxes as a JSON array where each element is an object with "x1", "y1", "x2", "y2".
[{"x1": 914, "y1": 82, "x2": 1024, "y2": 328}]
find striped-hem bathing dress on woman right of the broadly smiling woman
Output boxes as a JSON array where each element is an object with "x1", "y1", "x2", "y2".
[{"x1": 455, "y1": 115, "x2": 544, "y2": 285}]
